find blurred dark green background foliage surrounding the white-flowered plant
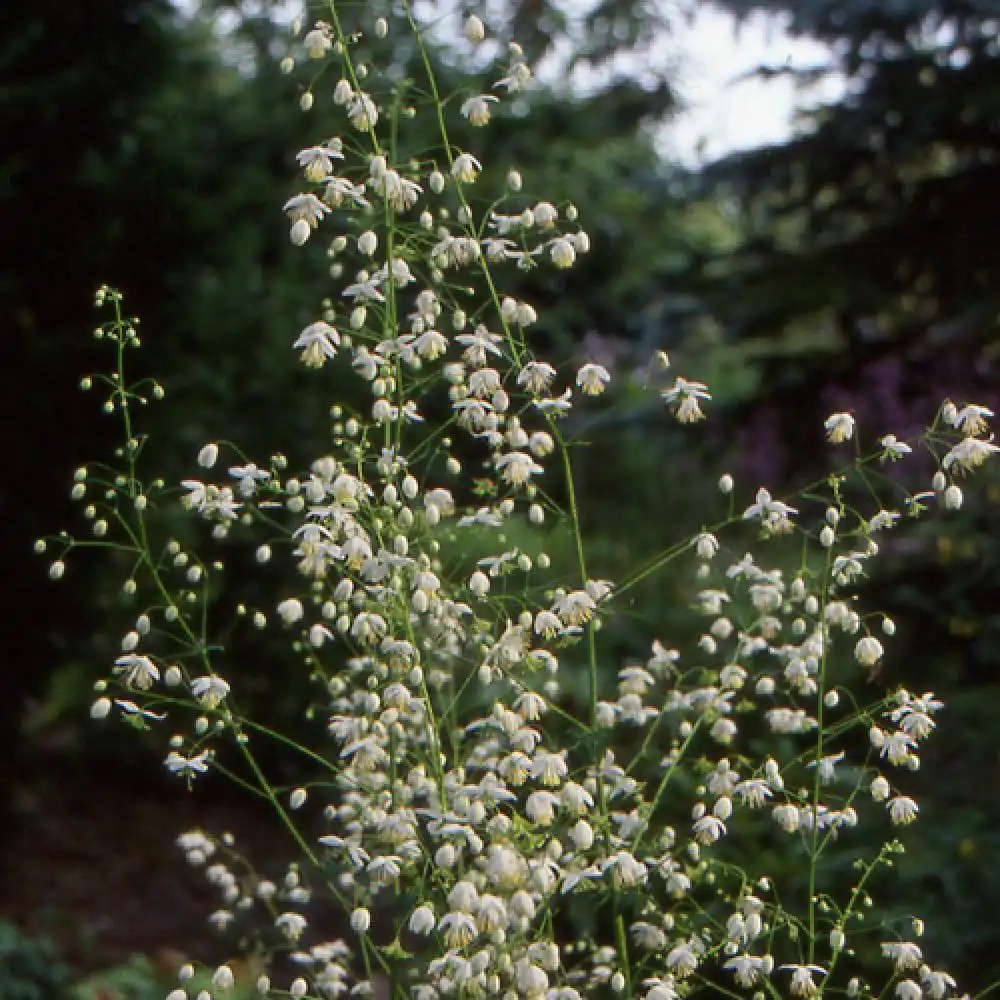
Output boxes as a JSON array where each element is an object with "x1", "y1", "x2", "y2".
[{"x1": 0, "y1": 0, "x2": 1000, "y2": 987}]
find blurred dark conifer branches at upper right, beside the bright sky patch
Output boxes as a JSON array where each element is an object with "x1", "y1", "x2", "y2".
[{"x1": 680, "y1": 0, "x2": 1000, "y2": 449}]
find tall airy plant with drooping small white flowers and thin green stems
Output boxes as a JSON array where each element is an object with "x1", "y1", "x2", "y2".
[{"x1": 39, "y1": 0, "x2": 997, "y2": 1000}]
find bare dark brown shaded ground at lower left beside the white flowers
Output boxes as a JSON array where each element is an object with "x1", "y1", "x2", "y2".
[{"x1": 0, "y1": 755, "x2": 287, "y2": 970}]
